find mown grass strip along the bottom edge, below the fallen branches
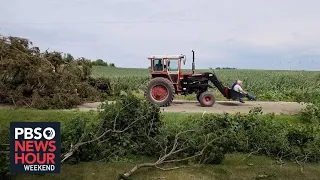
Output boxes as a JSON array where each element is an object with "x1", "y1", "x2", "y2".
[{"x1": 14, "y1": 154, "x2": 320, "y2": 180}]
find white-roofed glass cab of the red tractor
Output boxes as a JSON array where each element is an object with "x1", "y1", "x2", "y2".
[{"x1": 148, "y1": 55, "x2": 185, "y2": 84}]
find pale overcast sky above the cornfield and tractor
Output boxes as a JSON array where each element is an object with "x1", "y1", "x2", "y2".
[{"x1": 0, "y1": 0, "x2": 320, "y2": 70}]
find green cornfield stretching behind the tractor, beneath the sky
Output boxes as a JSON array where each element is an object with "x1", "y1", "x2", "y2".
[{"x1": 92, "y1": 66, "x2": 320, "y2": 101}]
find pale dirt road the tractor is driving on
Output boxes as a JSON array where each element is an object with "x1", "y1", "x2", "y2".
[{"x1": 77, "y1": 100, "x2": 305, "y2": 114}]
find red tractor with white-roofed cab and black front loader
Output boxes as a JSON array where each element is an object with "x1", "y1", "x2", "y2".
[{"x1": 144, "y1": 50, "x2": 244, "y2": 107}]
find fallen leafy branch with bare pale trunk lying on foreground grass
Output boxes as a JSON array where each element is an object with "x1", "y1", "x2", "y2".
[{"x1": 118, "y1": 130, "x2": 227, "y2": 180}]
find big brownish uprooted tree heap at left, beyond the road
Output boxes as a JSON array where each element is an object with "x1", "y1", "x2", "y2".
[{"x1": 0, "y1": 36, "x2": 110, "y2": 108}]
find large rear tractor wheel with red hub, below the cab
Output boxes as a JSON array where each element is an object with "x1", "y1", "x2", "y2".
[{"x1": 144, "y1": 77, "x2": 175, "y2": 107}]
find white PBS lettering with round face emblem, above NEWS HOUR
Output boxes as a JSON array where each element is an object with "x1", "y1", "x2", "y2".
[{"x1": 14, "y1": 127, "x2": 56, "y2": 140}]
